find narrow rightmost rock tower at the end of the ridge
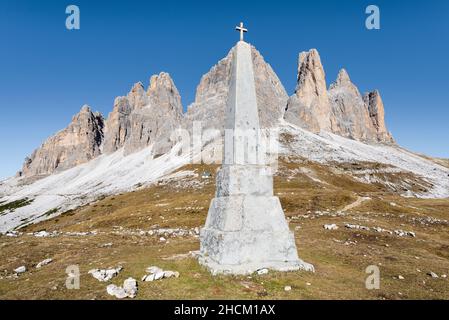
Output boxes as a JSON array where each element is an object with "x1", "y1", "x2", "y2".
[{"x1": 363, "y1": 90, "x2": 394, "y2": 142}]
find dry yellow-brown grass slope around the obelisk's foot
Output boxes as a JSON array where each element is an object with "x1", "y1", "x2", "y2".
[{"x1": 0, "y1": 159, "x2": 449, "y2": 299}]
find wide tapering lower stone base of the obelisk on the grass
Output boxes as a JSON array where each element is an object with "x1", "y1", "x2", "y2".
[{"x1": 199, "y1": 195, "x2": 314, "y2": 274}]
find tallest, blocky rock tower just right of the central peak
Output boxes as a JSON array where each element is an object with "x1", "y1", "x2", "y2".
[{"x1": 285, "y1": 49, "x2": 331, "y2": 133}]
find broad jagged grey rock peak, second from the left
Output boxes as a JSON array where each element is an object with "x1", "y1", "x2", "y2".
[{"x1": 103, "y1": 73, "x2": 182, "y2": 155}]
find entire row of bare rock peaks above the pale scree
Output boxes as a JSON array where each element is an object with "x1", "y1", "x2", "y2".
[{"x1": 18, "y1": 46, "x2": 394, "y2": 178}]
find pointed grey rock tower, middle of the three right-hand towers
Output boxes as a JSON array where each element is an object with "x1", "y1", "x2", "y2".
[{"x1": 329, "y1": 69, "x2": 377, "y2": 141}]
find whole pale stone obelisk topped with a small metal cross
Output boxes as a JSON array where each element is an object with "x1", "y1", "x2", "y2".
[{"x1": 199, "y1": 23, "x2": 313, "y2": 274}]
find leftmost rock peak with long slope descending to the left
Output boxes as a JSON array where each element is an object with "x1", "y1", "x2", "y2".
[{"x1": 21, "y1": 105, "x2": 103, "y2": 177}]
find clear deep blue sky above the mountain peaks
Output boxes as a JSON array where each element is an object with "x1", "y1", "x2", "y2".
[{"x1": 0, "y1": 0, "x2": 449, "y2": 177}]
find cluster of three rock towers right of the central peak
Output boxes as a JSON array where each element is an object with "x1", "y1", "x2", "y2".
[{"x1": 284, "y1": 49, "x2": 394, "y2": 143}]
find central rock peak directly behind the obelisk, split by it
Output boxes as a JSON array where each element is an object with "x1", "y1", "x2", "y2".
[{"x1": 185, "y1": 43, "x2": 288, "y2": 130}]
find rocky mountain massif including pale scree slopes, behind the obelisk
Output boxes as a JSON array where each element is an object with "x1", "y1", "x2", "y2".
[{"x1": 0, "y1": 46, "x2": 449, "y2": 232}]
